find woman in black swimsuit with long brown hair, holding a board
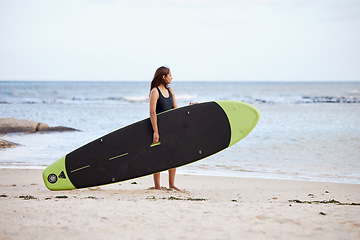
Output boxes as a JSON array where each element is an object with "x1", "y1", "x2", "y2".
[{"x1": 150, "y1": 67, "x2": 180, "y2": 191}]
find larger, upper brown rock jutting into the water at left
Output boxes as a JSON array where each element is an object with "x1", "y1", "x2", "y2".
[{"x1": 0, "y1": 118, "x2": 78, "y2": 134}]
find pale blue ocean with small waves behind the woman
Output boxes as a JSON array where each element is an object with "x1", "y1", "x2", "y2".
[{"x1": 0, "y1": 80, "x2": 360, "y2": 184}]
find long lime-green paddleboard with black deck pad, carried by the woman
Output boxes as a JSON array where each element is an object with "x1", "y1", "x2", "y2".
[{"x1": 43, "y1": 100, "x2": 260, "y2": 190}]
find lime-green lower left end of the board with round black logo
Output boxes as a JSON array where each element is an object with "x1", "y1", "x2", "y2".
[{"x1": 43, "y1": 156, "x2": 75, "y2": 190}]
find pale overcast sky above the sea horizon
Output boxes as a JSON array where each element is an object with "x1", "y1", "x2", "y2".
[{"x1": 0, "y1": 0, "x2": 360, "y2": 81}]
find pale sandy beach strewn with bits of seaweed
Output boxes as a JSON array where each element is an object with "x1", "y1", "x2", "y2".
[{"x1": 0, "y1": 169, "x2": 360, "y2": 239}]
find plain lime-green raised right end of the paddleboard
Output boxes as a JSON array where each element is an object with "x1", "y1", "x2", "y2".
[{"x1": 216, "y1": 100, "x2": 260, "y2": 146}]
